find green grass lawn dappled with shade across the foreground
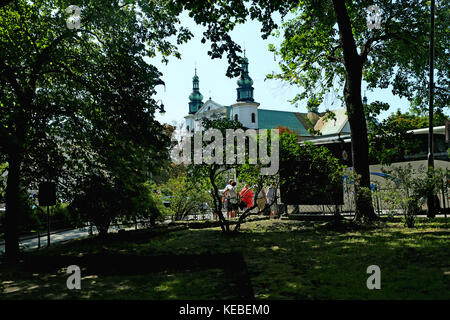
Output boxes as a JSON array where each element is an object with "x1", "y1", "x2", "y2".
[{"x1": 0, "y1": 218, "x2": 450, "y2": 299}]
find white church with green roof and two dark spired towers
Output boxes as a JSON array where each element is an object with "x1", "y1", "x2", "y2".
[{"x1": 185, "y1": 57, "x2": 350, "y2": 140}]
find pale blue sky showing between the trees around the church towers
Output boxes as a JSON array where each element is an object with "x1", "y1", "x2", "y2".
[{"x1": 148, "y1": 14, "x2": 409, "y2": 124}]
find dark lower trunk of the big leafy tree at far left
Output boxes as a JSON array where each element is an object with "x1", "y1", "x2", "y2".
[{"x1": 5, "y1": 150, "x2": 22, "y2": 261}]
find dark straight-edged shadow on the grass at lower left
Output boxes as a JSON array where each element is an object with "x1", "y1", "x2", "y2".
[{"x1": 0, "y1": 252, "x2": 253, "y2": 300}]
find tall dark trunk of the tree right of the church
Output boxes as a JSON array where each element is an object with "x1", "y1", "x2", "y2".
[{"x1": 333, "y1": 0, "x2": 377, "y2": 220}]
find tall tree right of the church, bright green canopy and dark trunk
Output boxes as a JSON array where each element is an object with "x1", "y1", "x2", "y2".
[{"x1": 180, "y1": 0, "x2": 450, "y2": 220}]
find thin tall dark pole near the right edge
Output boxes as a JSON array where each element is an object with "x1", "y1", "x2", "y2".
[{"x1": 427, "y1": 0, "x2": 435, "y2": 218}]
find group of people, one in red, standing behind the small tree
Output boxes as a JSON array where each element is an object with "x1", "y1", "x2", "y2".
[{"x1": 222, "y1": 179, "x2": 277, "y2": 219}]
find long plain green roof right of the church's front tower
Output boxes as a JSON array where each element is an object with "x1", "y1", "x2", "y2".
[{"x1": 258, "y1": 109, "x2": 310, "y2": 136}]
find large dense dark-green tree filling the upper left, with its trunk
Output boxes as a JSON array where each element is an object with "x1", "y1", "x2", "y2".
[{"x1": 0, "y1": 0, "x2": 191, "y2": 259}]
